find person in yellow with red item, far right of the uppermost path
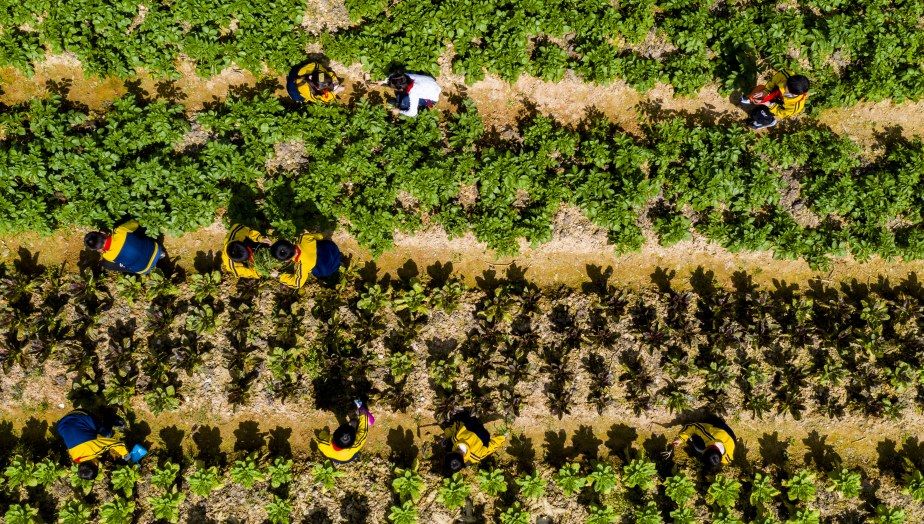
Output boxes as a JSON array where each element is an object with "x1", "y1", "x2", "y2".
[{"x1": 740, "y1": 71, "x2": 809, "y2": 129}]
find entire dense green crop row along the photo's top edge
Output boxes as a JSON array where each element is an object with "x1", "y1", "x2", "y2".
[{"x1": 0, "y1": 0, "x2": 924, "y2": 106}]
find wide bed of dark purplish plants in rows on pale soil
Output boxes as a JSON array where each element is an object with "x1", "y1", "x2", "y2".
[{"x1": 0, "y1": 258, "x2": 924, "y2": 420}]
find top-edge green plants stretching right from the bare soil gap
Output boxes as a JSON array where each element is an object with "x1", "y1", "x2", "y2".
[{"x1": 322, "y1": 0, "x2": 924, "y2": 107}]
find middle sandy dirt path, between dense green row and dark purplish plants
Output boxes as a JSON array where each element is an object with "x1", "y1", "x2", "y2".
[{"x1": 0, "y1": 216, "x2": 924, "y2": 287}]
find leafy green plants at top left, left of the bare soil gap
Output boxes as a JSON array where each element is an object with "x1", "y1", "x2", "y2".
[{"x1": 0, "y1": 0, "x2": 310, "y2": 78}]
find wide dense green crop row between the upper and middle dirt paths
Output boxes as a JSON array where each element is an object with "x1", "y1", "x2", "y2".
[{"x1": 0, "y1": 88, "x2": 924, "y2": 266}]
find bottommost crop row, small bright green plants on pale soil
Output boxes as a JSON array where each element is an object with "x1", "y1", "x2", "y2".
[{"x1": 0, "y1": 418, "x2": 924, "y2": 524}]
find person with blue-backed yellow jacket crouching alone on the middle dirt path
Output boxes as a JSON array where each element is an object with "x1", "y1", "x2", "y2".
[{"x1": 83, "y1": 220, "x2": 167, "y2": 275}]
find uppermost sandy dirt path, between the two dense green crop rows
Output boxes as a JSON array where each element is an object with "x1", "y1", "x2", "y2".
[{"x1": 0, "y1": 53, "x2": 924, "y2": 147}]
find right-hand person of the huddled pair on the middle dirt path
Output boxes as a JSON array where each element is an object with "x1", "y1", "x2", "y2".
[{"x1": 270, "y1": 233, "x2": 341, "y2": 289}]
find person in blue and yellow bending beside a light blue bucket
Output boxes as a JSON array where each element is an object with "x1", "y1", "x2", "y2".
[{"x1": 55, "y1": 410, "x2": 147, "y2": 480}]
